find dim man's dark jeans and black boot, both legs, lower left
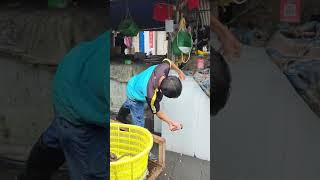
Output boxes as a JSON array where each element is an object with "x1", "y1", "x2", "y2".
[{"x1": 20, "y1": 113, "x2": 110, "y2": 180}]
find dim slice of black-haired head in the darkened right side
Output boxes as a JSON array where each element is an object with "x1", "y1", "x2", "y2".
[{"x1": 210, "y1": 48, "x2": 231, "y2": 116}]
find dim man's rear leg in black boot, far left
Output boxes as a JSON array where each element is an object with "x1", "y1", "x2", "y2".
[{"x1": 18, "y1": 118, "x2": 65, "y2": 180}]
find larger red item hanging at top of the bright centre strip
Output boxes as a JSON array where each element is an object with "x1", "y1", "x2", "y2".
[{"x1": 153, "y1": 3, "x2": 174, "y2": 22}]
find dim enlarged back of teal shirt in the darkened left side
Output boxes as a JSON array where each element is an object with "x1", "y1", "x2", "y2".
[{"x1": 53, "y1": 32, "x2": 110, "y2": 127}]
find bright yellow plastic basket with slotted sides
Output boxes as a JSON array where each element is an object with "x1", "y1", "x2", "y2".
[{"x1": 110, "y1": 123, "x2": 153, "y2": 180}]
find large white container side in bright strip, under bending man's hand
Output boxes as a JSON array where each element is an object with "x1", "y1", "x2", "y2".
[{"x1": 155, "y1": 71, "x2": 210, "y2": 161}]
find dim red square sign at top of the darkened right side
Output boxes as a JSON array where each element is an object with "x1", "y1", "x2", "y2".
[{"x1": 280, "y1": 0, "x2": 301, "y2": 23}]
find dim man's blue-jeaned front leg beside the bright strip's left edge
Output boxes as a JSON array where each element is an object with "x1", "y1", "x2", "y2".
[{"x1": 60, "y1": 119, "x2": 109, "y2": 180}]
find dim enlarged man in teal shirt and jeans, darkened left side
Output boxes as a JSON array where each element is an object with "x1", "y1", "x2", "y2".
[{"x1": 19, "y1": 32, "x2": 110, "y2": 180}]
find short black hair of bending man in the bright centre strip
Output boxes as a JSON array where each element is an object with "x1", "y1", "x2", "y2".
[{"x1": 160, "y1": 76, "x2": 182, "y2": 98}]
